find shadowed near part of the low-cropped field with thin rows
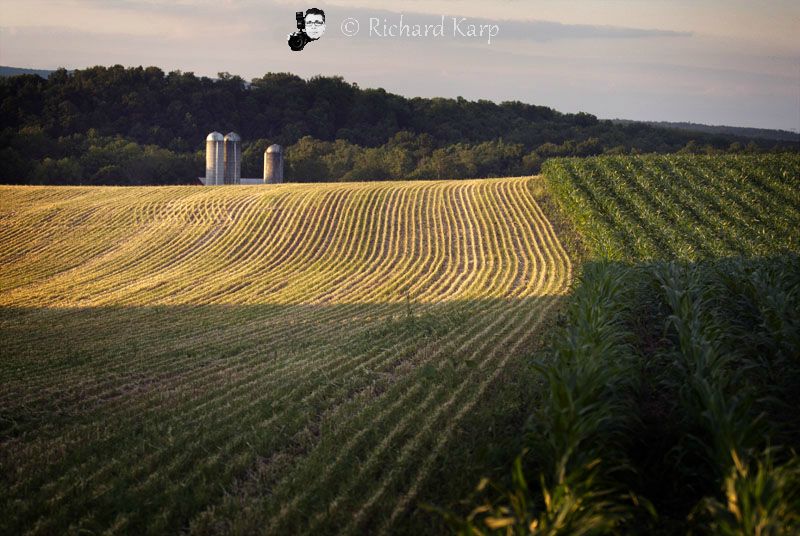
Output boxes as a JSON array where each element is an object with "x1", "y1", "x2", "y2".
[{"x1": 0, "y1": 296, "x2": 565, "y2": 534}]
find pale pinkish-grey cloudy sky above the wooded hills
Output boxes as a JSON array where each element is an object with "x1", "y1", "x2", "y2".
[{"x1": 0, "y1": 0, "x2": 800, "y2": 131}]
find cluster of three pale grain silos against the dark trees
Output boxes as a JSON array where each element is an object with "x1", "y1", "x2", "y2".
[{"x1": 200, "y1": 132, "x2": 283, "y2": 186}]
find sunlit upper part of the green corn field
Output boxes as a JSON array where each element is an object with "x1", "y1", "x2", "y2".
[{"x1": 544, "y1": 154, "x2": 800, "y2": 261}]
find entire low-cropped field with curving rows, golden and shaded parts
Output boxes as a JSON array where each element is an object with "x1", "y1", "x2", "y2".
[{"x1": 0, "y1": 178, "x2": 572, "y2": 534}]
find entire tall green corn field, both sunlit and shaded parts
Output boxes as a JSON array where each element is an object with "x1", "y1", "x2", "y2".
[{"x1": 445, "y1": 154, "x2": 800, "y2": 535}]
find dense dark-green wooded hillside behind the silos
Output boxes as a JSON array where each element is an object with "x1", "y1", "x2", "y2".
[{"x1": 0, "y1": 65, "x2": 798, "y2": 184}]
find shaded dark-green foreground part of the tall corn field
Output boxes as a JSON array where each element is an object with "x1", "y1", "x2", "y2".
[{"x1": 484, "y1": 253, "x2": 800, "y2": 534}]
